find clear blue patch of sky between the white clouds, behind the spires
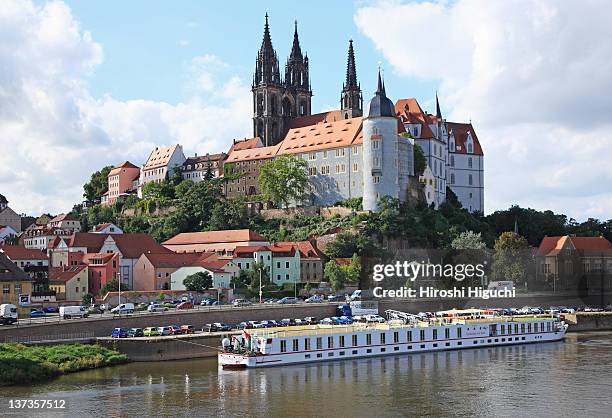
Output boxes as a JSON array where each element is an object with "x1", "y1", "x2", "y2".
[{"x1": 67, "y1": 0, "x2": 436, "y2": 112}]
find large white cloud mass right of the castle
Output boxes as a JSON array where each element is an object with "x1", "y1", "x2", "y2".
[{"x1": 355, "y1": 0, "x2": 612, "y2": 219}]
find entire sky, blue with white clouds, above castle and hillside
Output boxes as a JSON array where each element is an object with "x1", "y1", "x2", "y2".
[{"x1": 0, "y1": 0, "x2": 612, "y2": 220}]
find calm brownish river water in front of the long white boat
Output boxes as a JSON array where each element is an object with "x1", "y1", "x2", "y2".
[{"x1": 0, "y1": 332, "x2": 612, "y2": 418}]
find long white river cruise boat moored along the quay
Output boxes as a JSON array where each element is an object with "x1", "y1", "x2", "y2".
[{"x1": 218, "y1": 309, "x2": 568, "y2": 369}]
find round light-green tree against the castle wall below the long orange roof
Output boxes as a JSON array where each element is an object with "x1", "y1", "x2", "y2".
[{"x1": 259, "y1": 156, "x2": 308, "y2": 208}]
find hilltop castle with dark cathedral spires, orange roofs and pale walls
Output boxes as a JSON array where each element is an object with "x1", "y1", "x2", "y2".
[{"x1": 140, "y1": 14, "x2": 484, "y2": 212}]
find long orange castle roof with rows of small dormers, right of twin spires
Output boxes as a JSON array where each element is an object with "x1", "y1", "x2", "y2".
[{"x1": 278, "y1": 117, "x2": 362, "y2": 155}]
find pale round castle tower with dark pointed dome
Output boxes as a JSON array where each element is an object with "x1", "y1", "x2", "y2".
[{"x1": 363, "y1": 71, "x2": 400, "y2": 212}]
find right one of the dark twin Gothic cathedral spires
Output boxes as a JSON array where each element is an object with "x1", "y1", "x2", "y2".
[{"x1": 282, "y1": 21, "x2": 312, "y2": 123}]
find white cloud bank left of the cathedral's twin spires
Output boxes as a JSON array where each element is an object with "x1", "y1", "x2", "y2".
[{"x1": 0, "y1": 0, "x2": 251, "y2": 214}]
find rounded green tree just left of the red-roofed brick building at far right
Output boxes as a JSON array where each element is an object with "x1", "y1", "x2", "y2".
[{"x1": 491, "y1": 232, "x2": 531, "y2": 284}]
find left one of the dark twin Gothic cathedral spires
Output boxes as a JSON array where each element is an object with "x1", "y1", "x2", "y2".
[{"x1": 251, "y1": 13, "x2": 285, "y2": 146}]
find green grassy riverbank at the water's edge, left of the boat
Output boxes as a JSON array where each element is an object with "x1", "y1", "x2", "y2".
[{"x1": 0, "y1": 344, "x2": 128, "y2": 386}]
